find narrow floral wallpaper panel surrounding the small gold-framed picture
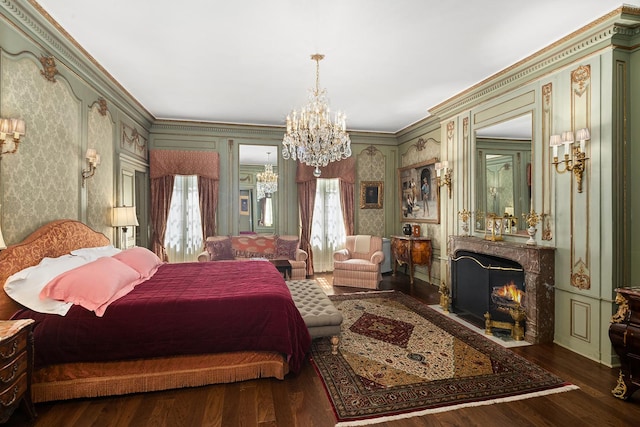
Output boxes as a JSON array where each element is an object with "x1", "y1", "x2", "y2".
[{"x1": 355, "y1": 146, "x2": 384, "y2": 236}]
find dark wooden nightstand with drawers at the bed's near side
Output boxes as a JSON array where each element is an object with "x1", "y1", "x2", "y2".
[{"x1": 0, "y1": 319, "x2": 36, "y2": 423}]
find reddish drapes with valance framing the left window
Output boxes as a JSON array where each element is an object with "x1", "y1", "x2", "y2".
[{"x1": 149, "y1": 150, "x2": 220, "y2": 261}]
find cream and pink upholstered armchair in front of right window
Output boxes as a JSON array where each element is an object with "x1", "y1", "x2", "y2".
[{"x1": 333, "y1": 235, "x2": 384, "y2": 289}]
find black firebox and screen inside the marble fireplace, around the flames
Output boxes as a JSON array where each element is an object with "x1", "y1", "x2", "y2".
[{"x1": 451, "y1": 251, "x2": 526, "y2": 328}]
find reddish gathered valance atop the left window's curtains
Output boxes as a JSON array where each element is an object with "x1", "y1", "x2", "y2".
[{"x1": 149, "y1": 150, "x2": 220, "y2": 180}]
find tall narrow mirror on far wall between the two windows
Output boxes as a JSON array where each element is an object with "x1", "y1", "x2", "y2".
[{"x1": 238, "y1": 144, "x2": 278, "y2": 234}]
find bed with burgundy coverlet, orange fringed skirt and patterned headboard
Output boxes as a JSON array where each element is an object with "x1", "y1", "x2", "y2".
[{"x1": 0, "y1": 220, "x2": 310, "y2": 402}]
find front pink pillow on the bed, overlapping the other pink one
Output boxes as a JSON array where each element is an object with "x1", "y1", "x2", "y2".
[{"x1": 40, "y1": 257, "x2": 146, "y2": 317}]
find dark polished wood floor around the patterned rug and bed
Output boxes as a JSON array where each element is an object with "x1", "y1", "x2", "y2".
[{"x1": 7, "y1": 274, "x2": 640, "y2": 427}]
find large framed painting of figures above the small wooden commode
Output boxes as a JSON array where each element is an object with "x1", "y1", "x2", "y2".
[{"x1": 398, "y1": 158, "x2": 440, "y2": 224}]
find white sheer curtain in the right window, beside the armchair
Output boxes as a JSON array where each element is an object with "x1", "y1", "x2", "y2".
[{"x1": 311, "y1": 178, "x2": 346, "y2": 273}]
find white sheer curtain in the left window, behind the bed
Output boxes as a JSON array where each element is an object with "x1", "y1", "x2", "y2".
[{"x1": 164, "y1": 175, "x2": 203, "y2": 262}]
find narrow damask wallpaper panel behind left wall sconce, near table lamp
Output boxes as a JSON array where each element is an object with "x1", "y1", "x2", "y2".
[{"x1": 84, "y1": 103, "x2": 115, "y2": 242}]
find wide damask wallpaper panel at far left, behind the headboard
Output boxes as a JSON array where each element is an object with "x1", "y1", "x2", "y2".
[{"x1": 0, "y1": 55, "x2": 84, "y2": 244}]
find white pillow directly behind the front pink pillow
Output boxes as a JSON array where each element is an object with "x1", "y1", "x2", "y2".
[{"x1": 4, "y1": 255, "x2": 89, "y2": 316}]
